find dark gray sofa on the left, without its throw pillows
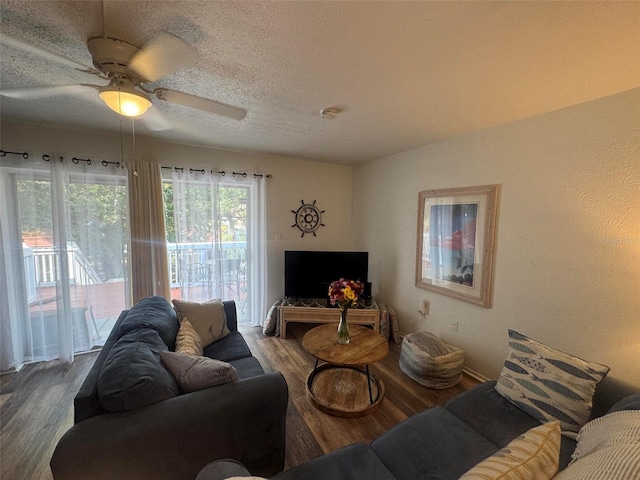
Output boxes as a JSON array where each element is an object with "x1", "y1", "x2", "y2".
[{"x1": 50, "y1": 297, "x2": 288, "y2": 480}]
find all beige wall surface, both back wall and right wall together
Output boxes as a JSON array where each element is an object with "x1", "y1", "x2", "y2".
[{"x1": 1, "y1": 89, "x2": 640, "y2": 386}]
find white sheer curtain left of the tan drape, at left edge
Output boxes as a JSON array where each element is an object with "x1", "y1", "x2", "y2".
[{"x1": 0, "y1": 155, "x2": 128, "y2": 371}]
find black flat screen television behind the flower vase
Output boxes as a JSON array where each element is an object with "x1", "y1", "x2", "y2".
[{"x1": 284, "y1": 250, "x2": 370, "y2": 298}]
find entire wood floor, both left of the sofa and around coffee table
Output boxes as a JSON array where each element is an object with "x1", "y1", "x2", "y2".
[{"x1": 0, "y1": 324, "x2": 478, "y2": 480}]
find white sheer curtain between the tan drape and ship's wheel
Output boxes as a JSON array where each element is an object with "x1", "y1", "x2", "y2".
[{"x1": 165, "y1": 169, "x2": 266, "y2": 325}]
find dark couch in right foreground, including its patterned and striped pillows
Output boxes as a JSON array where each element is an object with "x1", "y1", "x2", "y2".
[{"x1": 197, "y1": 331, "x2": 640, "y2": 480}]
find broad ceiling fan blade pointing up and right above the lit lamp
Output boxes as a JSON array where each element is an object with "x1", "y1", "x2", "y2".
[{"x1": 129, "y1": 33, "x2": 198, "y2": 82}]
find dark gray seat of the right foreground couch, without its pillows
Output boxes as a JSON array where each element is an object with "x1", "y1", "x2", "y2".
[{"x1": 197, "y1": 382, "x2": 640, "y2": 480}]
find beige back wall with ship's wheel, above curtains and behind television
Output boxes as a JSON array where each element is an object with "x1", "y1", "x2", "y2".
[{"x1": 1, "y1": 120, "x2": 351, "y2": 305}]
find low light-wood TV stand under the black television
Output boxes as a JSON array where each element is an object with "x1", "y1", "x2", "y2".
[{"x1": 278, "y1": 298, "x2": 380, "y2": 338}]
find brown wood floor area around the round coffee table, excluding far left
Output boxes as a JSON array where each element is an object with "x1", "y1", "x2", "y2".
[{"x1": 242, "y1": 324, "x2": 478, "y2": 468}]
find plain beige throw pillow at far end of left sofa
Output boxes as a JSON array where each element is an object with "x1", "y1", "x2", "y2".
[{"x1": 171, "y1": 299, "x2": 229, "y2": 347}]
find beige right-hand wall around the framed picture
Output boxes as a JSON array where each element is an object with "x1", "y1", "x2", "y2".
[{"x1": 353, "y1": 89, "x2": 640, "y2": 386}]
